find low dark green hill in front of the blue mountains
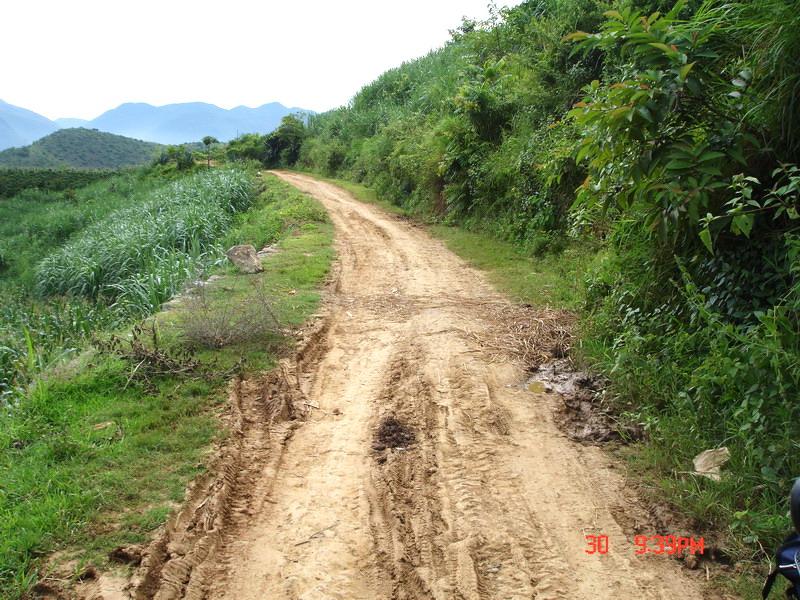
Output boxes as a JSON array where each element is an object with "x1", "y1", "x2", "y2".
[{"x1": 0, "y1": 128, "x2": 160, "y2": 169}]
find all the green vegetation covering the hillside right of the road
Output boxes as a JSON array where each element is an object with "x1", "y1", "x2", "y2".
[{"x1": 252, "y1": 0, "x2": 800, "y2": 576}]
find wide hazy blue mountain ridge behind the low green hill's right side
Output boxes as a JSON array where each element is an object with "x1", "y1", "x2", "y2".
[{"x1": 87, "y1": 102, "x2": 309, "y2": 144}]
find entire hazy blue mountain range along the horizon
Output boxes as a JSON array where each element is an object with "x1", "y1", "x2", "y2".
[{"x1": 0, "y1": 100, "x2": 311, "y2": 150}]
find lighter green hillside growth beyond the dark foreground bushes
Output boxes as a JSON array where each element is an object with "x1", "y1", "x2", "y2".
[{"x1": 299, "y1": 0, "x2": 602, "y2": 250}]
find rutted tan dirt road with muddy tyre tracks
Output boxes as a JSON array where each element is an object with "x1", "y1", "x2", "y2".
[{"x1": 119, "y1": 172, "x2": 702, "y2": 600}]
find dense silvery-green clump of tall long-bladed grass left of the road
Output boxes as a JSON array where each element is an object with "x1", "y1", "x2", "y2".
[{"x1": 36, "y1": 167, "x2": 254, "y2": 314}]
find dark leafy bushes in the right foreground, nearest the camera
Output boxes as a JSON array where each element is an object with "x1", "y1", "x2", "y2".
[{"x1": 570, "y1": 0, "x2": 800, "y2": 551}]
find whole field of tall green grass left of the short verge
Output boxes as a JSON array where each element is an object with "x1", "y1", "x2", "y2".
[{"x1": 0, "y1": 168, "x2": 254, "y2": 406}]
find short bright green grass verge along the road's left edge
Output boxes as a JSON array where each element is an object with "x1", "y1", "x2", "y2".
[{"x1": 0, "y1": 175, "x2": 333, "y2": 598}]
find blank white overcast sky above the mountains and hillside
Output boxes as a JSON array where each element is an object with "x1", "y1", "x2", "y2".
[{"x1": 0, "y1": 0, "x2": 519, "y2": 119}]
